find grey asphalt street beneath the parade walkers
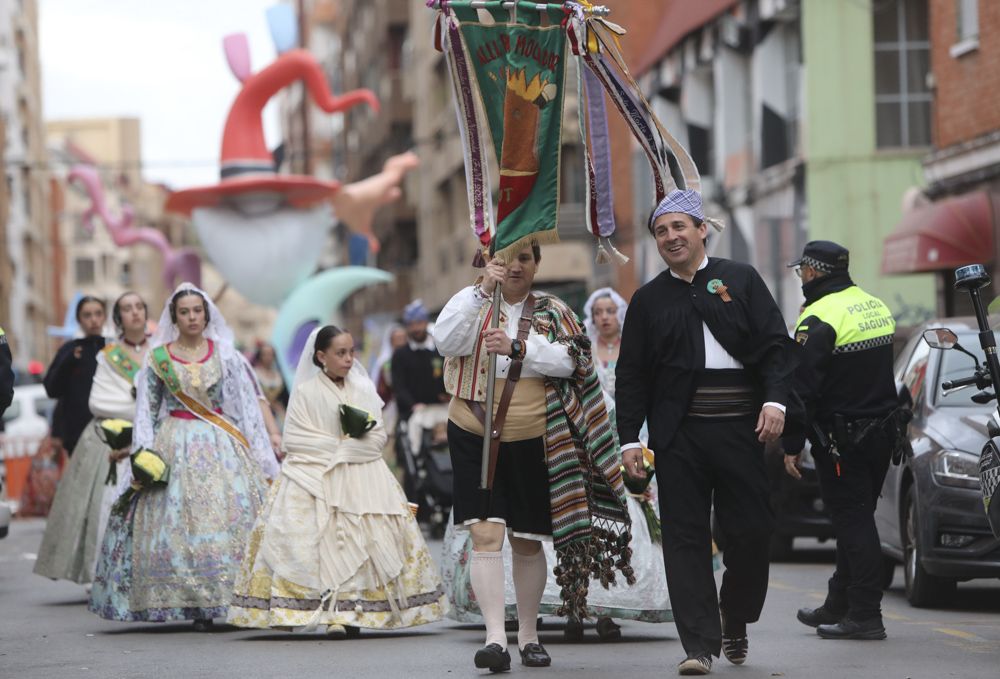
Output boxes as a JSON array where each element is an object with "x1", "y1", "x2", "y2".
[{"x1": 0, "y1": 520, "x2": 1000, "y2": 679}]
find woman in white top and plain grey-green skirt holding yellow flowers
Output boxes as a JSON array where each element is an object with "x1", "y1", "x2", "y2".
[{"x1": 35, "y1": 292, "x2": 148, "y2": 584}]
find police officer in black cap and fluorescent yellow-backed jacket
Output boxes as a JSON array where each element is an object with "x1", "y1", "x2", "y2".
[{"x1": 783, "y1": 241, "x2": 898, "y2": 639}]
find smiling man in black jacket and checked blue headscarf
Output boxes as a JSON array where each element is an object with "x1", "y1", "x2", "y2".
[{"x1": 615, "y1": 190, "x2": 795, "y2": 675}]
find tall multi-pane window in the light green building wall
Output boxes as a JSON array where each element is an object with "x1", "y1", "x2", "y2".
[{"x1": 874, "y1": 0, "x2": 931, "y2": 148}]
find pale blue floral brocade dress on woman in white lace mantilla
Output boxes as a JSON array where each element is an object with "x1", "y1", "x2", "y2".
[{"x1": 89, "y1": 345, "x2": 268, "y2": 622}]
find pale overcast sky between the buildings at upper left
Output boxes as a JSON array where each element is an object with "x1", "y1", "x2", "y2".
[{"x1": 39, "y1": 0, "x2": 280, "y2": 188}]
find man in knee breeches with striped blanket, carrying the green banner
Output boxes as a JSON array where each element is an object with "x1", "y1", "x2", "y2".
[{"x1": 434, "y1": 245, "x2": 633, "y2": 672}]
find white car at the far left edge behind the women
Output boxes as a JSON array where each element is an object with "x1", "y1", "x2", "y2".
[{"x1": 0, "y1": 384, "x2": 56, "y2": 538}]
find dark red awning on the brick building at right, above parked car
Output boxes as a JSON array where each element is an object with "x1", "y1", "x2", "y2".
[{"x1": 882, "y1": 191, "x2": 995, "y2": 274}]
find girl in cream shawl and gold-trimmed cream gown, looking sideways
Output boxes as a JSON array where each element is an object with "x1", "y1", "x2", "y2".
[{"x1": 229, "y1": 326, "x2": 447, "y2": 637}]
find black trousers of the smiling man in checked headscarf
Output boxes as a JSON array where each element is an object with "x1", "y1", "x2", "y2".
[{"x1": 656, "y1": 415, "x2": 774, "y2": 656}]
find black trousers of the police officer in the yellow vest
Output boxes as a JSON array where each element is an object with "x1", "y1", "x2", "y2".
[{"x1": 813, "y1": 431, "x2": 891, "y2": 620}]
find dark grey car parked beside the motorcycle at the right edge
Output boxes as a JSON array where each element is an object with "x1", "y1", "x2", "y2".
[{"x1": 875, "y1": 318, "x2": 1000, "y2": 606}]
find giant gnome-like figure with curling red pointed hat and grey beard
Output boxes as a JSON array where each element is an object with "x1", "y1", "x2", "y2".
[{"x1": 166, "y1": 5, "x2": 379, "y2": 307}]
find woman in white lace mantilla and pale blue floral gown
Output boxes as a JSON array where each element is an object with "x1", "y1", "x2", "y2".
[{"x1": 90, "y1": 283, "x2": 278, "y2": 631}]
